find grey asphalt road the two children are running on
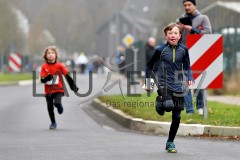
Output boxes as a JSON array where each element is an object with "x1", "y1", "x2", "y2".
[{"x1": 0, "y1": 75, "x2": 240, "y2": 160}]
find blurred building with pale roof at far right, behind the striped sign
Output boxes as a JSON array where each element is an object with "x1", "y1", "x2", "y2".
[{"x1": 201, "y1": 1, "x2": 240, "y2": 77}]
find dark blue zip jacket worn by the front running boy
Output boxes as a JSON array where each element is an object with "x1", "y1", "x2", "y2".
[{"x1": 146, "y1": 42, "x2": 194, "y2": 92}]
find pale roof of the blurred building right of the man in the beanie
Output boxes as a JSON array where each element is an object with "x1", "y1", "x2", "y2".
[{"x1": 201, "y1": 1, "x2": 240, "y2": 13}]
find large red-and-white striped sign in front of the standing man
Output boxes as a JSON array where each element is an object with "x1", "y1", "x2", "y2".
[{"x1": 187, "y1": 34, "x2": 223, "y2": 89}]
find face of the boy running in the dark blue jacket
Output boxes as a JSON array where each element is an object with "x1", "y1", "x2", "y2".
[{"x1": 165, "y1": 26, "x2": 181, "y2": 46}]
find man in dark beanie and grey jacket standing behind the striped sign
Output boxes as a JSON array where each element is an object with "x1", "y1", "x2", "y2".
[{"x1": 179, "y1": 0, "x2": 212, "y2": 115}]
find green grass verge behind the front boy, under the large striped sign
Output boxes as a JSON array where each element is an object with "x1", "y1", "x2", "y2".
[{"x1": 99, "y1": 94, "x2": 240, "y2": 127}]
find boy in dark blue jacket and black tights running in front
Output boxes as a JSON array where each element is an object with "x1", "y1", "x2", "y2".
[{"x1": 146, "y1": 23, "x2": 194, "y2": 153}]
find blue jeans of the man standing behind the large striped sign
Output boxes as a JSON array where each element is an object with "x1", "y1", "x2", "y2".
[{"x1": 184, "y1": 89, "x2": 204, "y2": 113}]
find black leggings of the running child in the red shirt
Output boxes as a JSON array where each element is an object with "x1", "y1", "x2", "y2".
[{"x1": 46, "y1": 92, "x2": 63, "y2": 123}]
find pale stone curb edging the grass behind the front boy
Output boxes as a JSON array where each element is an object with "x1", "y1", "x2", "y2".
[{"x1": 92, "y1": 99, "x2": 240, "y2": 136}]
